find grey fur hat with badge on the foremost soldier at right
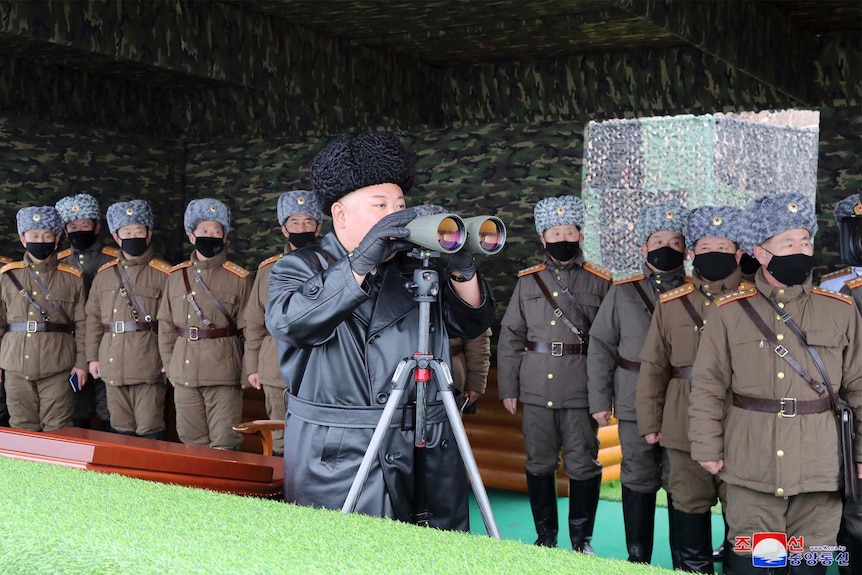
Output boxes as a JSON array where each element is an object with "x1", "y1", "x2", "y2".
[{"x1": 737, "y1": 192, "x2": 817, "y2": 254}]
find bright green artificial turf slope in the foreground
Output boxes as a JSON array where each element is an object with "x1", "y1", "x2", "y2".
[{"x1": 0, "y1": 457, "x2": 680, "y2": 575}]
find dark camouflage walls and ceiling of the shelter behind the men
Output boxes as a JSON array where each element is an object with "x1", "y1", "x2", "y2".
[{"x1": 0, "y1": 0, "x2": 862, "y2": 328}]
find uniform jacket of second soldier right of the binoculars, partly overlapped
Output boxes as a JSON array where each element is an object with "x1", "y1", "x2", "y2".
[{"x1": 587, "y1": 264, "x2": 685, "y2": 421}]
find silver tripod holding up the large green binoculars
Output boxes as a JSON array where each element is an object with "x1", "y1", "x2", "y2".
[{"x1": 341, "y1": 252, "x2": 500, "y2": 539}]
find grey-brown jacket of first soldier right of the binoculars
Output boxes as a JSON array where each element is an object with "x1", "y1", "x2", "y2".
[{"x1": 497, "y1": 256, "x2": 611, "y2": 409}]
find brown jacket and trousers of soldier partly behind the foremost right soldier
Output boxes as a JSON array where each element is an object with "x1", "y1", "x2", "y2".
[{"x1": 637, "y1": 267, "x2": 747, "y2": 513}]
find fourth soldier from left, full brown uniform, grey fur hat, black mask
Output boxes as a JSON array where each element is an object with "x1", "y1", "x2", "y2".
[{"x1": 157, "y1": 198, "x2": 251, "y2": 449}]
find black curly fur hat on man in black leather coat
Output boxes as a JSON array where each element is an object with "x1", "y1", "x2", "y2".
[{"x1": 311, "y1": 132, "x2": 414, "y2": 215}]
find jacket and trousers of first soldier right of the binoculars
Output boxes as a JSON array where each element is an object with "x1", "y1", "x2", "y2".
[{"x1": 497, "y1": 257, "x2": 611, "y2": 481}]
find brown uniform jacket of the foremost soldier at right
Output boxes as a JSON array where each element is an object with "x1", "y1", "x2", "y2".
[{"x1": 689, "y1": 271, "x2": 862, "y2": 496}]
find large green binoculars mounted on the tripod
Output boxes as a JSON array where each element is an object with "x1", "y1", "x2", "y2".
[{"x1": 404, "y1": 213, "x2": 506, "y2": 255}]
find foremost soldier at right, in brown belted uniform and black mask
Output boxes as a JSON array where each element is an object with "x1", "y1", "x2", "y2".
[{"x1": 689, "y1": 193, "x2": 862, "y2": 575}]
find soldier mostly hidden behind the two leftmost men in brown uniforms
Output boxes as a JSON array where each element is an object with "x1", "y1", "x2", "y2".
[{"x1": 54, "y1": 194, "x2": 120, "y2": 431}]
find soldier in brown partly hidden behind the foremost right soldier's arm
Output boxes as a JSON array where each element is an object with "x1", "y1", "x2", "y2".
[{"x1": 636, "y1": 206, "x2": 742, "y2": 573}]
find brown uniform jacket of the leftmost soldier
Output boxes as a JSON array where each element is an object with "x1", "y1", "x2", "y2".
[{"x1": 0, "y1": 255, "x2": 87, "y2": 379}]
